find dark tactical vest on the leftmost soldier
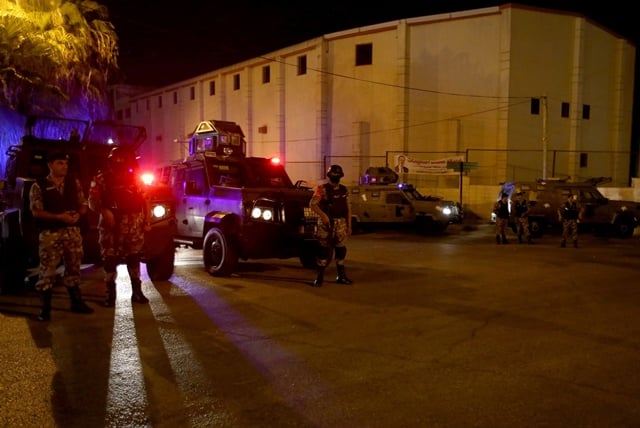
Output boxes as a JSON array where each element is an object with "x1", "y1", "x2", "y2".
[{"x1": 35, "y1": 176, "x2": 80, "y2": 230}]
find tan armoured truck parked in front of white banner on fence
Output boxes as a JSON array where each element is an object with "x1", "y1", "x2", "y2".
[{"x1": 350, "y1": 167, "x2": 462, "y2": 234}]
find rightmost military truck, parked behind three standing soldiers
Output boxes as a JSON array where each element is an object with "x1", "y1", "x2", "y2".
[{"x1": 492, "y1": 177, "x2": 640, "y2": 238}]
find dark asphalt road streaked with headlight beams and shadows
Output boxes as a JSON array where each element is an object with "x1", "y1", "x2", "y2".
[{"x1": 0, "y1": 225, "x2": 640, "y2": 427}]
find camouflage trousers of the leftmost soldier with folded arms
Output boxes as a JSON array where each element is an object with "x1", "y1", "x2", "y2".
[{"x1": 35, "y1": 227, "x2": 84, "y2": 291}]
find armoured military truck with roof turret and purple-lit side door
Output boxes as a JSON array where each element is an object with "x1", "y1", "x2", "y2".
[{"x1": 157, "y1": 120, "x2": 317, "y2": 276}]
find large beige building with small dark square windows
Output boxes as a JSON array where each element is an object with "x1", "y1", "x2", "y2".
[{"x1": 112, "y1": 4, "x2": 635, "y2": 216}]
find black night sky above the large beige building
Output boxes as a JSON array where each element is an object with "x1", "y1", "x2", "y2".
[{"x1": 100, "y1": 0, "x2": 640, "y2": 86}]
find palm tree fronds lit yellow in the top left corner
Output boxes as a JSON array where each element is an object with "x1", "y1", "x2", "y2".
[{"x1": 0, "y1": 0, "x2": 118, "y2": 119}]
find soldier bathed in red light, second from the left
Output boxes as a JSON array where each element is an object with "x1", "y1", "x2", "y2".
[{"x1": 89, "y1": 147, "x2": 149, "y2": 307}]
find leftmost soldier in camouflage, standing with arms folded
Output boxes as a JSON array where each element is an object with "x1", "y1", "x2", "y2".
[{"x1": 29, "y1": 151, "x2": 93, "y2": 321}]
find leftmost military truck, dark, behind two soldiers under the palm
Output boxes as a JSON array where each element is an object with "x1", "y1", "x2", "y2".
[{"x1": 0, "y1": 116, "x2": 176, "y2": 293}]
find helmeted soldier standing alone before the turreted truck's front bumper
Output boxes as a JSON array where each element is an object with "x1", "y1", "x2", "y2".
[{"x1": 309, "y1": 165, "x2": 353, "y2": 287}]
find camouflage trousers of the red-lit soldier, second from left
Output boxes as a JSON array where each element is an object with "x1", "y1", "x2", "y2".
[{"x1": 98, "y1": 213, "x2": 144, "y2": 282}]
